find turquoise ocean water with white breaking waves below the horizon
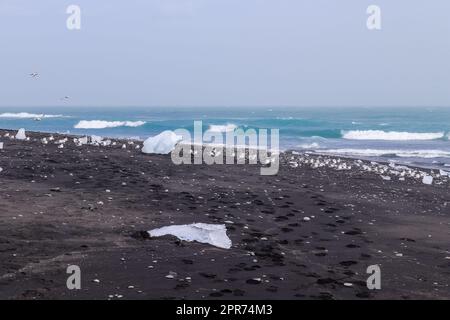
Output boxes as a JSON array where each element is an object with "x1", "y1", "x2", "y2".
[{"x1": 0, "y1": 107, "x2": 450, "y2": 167}]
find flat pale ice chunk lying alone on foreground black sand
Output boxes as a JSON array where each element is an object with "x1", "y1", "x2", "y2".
[{"x1": 148, "y1": 223, "x2": 231, "y2": 249}]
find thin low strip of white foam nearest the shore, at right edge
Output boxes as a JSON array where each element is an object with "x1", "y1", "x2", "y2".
[{"x1": 320, "y1": 149, "x2": 450, "y2": 158}]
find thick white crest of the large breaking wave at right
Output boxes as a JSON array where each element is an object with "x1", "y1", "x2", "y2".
[{"x1": 341, "y1": 130, "x2": 445, "y2": 141}]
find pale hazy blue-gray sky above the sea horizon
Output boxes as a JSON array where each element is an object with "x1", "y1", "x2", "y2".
[{"x1": 0, "y1": 0, "x2": 450, "y2": 106}]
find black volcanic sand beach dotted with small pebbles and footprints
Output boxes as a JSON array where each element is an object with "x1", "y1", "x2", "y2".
[{"x1": 0, "y1": 131, "x2": 450, "y2": 299}]
